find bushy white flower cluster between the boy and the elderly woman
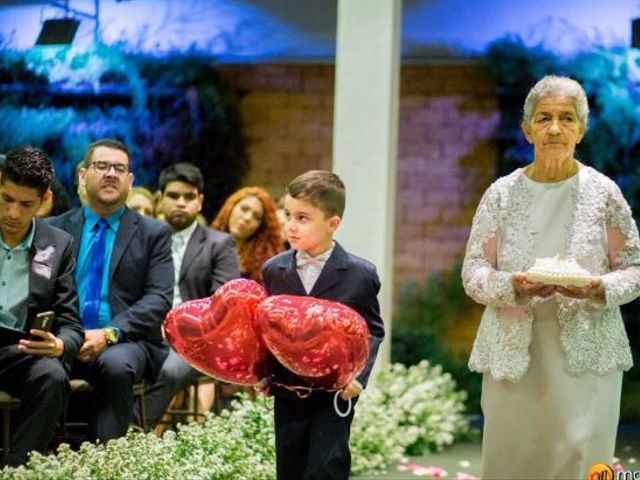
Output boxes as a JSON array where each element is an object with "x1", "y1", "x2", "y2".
[{"x1": 350, "y1": 360, "x2": 470, "y2": 474}]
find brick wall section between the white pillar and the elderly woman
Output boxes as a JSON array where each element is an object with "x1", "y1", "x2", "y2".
[{"x1": 394, "y1": 64, "x2": 499, "y2": 286}]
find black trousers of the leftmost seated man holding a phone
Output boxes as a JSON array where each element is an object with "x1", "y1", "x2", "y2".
[{"x1": 0, "y1": 345, "x2": 69, "y2": 465}]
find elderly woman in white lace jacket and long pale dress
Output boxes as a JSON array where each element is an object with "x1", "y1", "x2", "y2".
[{"x1": 462, "y1": 76, "x2": 640, "y2": 480}]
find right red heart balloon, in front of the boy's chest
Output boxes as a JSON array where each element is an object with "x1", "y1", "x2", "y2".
[{"x1": 256, "y1": 295, "x2": 369, "y2": 390}]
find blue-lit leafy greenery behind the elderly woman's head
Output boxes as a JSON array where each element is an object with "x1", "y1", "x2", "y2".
[{"x1": 487, "y1": 36, "x2": 640, "y2": 219}]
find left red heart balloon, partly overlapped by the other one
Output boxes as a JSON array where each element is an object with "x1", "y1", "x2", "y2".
[{"x1": 164, "y1": 279, "x2": 267, "y2": 385}]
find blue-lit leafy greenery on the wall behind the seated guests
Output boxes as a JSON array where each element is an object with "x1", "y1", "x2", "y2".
[{"x1": 0, "y1": 45, "x2": 248, "y2": 217}]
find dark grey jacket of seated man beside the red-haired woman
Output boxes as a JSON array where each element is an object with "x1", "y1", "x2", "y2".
[{"x1": 178, "y1": 225, "x2": 240, "y2": 301}]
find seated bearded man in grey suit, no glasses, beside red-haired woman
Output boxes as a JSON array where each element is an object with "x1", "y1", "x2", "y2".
[{"x1": 140, "y1": 163, "x2": 240, "y2": 432}]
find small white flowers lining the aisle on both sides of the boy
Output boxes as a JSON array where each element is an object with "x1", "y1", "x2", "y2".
[{"x1": 0, "y1": 361, "x2": 469, "y2": 480}]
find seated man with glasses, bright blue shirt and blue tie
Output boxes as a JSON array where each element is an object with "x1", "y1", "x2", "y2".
[{"x1": 51, "y1": 139, "x2": 174, "y2": 442}]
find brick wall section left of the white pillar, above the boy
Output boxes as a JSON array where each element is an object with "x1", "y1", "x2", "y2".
[{"x1": 222, "y1": 65, "x2": 333, "y2": 197}]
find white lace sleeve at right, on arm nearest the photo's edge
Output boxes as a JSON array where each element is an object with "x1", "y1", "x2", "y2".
[{"x1": 602, "y1": 185, "x2": 640, "y2": 307}]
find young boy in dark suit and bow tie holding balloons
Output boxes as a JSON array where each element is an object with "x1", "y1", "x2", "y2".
[{"x1": 259, "y1": 170, "x2": 384, "y2": 480}]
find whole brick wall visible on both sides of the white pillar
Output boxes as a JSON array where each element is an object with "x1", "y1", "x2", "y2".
[{"x1": 222, "y1": 64, "x2": 499, "y2": 287}]
